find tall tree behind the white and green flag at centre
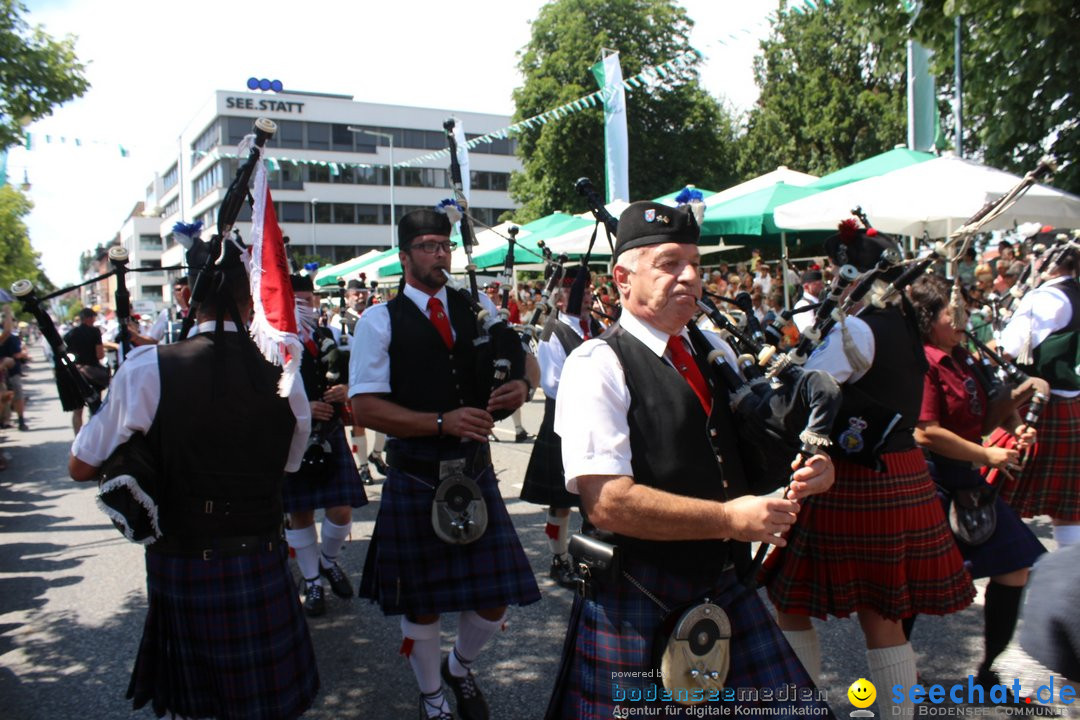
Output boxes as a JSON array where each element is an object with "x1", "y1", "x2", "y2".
[{"x1": 510, "y1": 0, "x2": 735, "y2": 222}]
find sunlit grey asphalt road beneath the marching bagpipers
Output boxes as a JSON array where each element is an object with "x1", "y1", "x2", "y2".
[{"x1": 0, "y1": 345, "x2": 1080, "y2": 720}]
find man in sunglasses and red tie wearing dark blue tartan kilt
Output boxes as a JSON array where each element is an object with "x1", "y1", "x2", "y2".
[{"x1": 349, "y1": 209, "x2": 540, "y2": 720}]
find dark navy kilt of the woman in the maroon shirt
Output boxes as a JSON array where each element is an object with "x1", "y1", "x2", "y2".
[{"x1": 927, "y1": 461, "x2": 1047, "y2": 579}]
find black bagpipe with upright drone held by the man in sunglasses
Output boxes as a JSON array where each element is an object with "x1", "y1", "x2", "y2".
[{"x1": 443, "y1": 118, "x2": 525, "y2": 420}]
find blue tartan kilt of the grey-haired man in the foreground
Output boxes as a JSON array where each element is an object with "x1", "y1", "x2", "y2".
[{"x1": 546, "y1": 560, "x2": 835, "y2": 720}]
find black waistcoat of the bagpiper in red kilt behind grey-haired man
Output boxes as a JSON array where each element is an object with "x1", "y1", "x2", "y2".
[{"x1": 841, "y1": 299, "x2": 928, "y2": 452}]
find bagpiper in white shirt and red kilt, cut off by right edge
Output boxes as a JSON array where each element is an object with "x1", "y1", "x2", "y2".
[{"x1": 987, "y1": 249, "x2": 1080, "y2": 545}]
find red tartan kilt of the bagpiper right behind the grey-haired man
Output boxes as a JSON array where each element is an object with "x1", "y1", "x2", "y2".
[{"x1": 761, "y1": 448, "x2": 975, "y2": 620}]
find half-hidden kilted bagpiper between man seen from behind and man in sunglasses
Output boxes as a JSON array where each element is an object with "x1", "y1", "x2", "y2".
[{"x1": 283, "y1": 274, "x2": 367, "y2": 617}]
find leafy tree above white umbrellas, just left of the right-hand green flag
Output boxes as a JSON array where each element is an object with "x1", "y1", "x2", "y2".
[{"x1": 739, "y1": 0, "x2": 908, "y2": 178}]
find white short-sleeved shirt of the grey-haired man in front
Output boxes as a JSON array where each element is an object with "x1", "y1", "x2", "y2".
[{"x1": 555, "y1": 310, "x2": 737, "y2": 493}]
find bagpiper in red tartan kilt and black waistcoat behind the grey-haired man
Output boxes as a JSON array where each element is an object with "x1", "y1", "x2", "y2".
[{"x1": 762, "y1": 220, "x2": 975, "y2": 715}]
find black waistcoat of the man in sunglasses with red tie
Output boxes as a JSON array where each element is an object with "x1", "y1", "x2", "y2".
[{"x1": 387, "y1": 291, "x2": 487, "y2": 445}]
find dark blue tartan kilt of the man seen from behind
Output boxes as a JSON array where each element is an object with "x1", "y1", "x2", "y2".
[{"x1": 127, "y1": 543, "x2": 319, "y2": 720}]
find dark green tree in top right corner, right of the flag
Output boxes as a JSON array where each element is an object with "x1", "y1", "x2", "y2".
[{"x1": 914, "y1": 0, "x2": 1080, "y2": 193}]
